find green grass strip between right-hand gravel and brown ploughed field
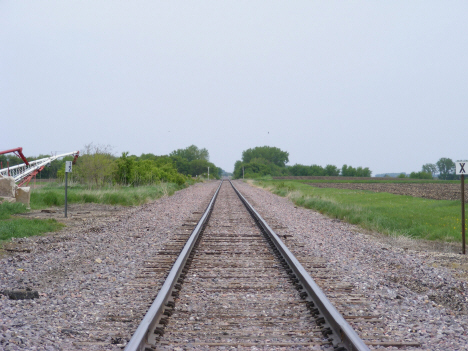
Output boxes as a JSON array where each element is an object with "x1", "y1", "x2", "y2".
[{"x1": 255, "y1": 180, "x2": 461, "y2": 242}]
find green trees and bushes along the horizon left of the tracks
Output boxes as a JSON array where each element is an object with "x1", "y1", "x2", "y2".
[{"x1": 0, "y1": 143, "x2": 223, "y2": 186}]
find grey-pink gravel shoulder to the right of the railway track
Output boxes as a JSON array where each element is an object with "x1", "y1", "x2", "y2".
[{"x1": 236, "y1": 181, "x2": 468, "y2": 350}]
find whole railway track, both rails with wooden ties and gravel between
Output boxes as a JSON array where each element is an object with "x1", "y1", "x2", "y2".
[{"x1": 126, "y1": 181, "x2": 368, "y2": 350}]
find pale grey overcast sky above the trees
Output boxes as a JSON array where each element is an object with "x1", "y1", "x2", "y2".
[{"x1": 0, "y1": 0, "x2": 468, "y2": 174}]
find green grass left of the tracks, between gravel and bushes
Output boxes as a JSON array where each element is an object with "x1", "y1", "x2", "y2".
[{"x1": 0, "y1": 183, "x2": 188, "y2": 242}]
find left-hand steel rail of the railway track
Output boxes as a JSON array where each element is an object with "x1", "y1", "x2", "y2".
[{"x1": 125, "y1": 181, "x2": 223, "y2": 351}]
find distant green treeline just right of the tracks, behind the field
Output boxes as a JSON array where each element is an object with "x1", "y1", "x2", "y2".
[{"x1": 234, "y1": 146, "x2": 372, "y2": 178}]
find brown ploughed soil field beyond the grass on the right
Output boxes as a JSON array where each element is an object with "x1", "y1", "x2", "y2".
[{"x1": 308, "y1": 183, "x2": 468, "y2": 202}]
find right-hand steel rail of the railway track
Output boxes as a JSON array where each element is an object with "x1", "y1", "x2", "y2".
[{"x1": 229, "y1": 181, "x2": 369, "y2": 351}]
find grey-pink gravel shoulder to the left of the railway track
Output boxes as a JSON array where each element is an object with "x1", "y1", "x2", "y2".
[{"x1": 0, "y1": 182, "x2": 218, "y2": 350}]
